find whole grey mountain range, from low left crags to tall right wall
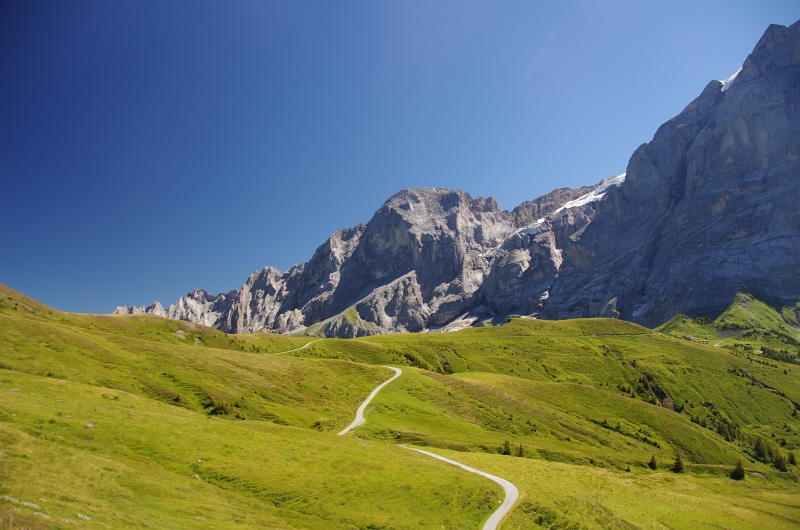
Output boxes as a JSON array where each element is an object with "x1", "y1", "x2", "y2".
[{"x1": 115, "y1": 22, "x2": 800, "y2": 337}]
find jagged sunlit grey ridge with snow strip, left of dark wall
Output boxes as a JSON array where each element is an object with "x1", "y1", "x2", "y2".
[{"x1": 115, "y1": 176, "x2": 624, "y2": 337}]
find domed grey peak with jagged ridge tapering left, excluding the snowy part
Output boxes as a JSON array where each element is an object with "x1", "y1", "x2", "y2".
[{"x1": 115, "y1": 188, "x2": 536, "y2": 336}]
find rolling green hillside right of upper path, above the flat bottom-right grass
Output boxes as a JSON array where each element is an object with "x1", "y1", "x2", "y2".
[{"x1": 292, "y1": 319, "x2": 800, "y2": 465}]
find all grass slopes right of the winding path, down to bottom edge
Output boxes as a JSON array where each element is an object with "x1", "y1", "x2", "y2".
[{"x1": 297, "y1": 319, "x2": 800, "y2": 528}]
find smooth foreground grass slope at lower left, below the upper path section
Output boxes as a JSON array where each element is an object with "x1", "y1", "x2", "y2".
[{"x1": 0, "y1": 370, "x2": 500, "y2": 528}]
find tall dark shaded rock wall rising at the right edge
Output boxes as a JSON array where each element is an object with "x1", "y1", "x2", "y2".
[{"x1": 544, "y1": 19, "x2": 800, "y2": 326}]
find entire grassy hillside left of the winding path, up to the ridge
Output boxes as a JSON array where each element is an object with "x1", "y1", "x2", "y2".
[{"x1": 0, "y1": 284, "x2": 502, "y2": 528}]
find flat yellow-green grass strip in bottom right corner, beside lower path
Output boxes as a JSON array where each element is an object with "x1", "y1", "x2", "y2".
[{"x1": 432, "y1": 450, "x2": 800, "y2": 530}]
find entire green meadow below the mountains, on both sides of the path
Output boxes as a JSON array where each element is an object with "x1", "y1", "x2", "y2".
[{"x1": 0, "y1": 280, "x2": 800, "y2": 529}]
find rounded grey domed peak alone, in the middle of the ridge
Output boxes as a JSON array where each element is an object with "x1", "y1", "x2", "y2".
[{"x1": 333, "y1": 188, "x2": 513, "y2": 331}]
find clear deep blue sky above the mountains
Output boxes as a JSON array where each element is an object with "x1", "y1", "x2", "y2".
[{"x1": 0, "y1": 0, "x2": 800, "y2": 312}]
